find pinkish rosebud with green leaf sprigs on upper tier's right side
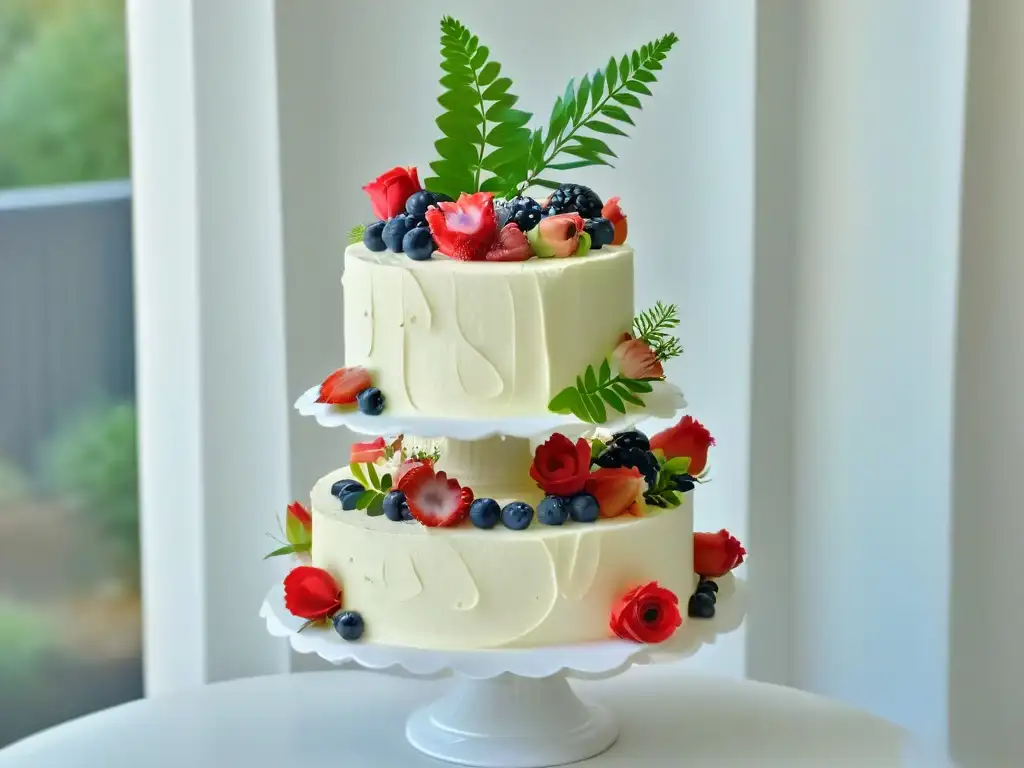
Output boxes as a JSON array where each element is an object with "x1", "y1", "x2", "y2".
[{"x1": 548, "y1": 302, "x2": 683, "y2": 424}]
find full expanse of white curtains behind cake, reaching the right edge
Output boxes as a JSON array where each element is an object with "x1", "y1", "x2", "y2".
[{"x1": 130, "y1": 0, "x2": 1024, "y2": 765}]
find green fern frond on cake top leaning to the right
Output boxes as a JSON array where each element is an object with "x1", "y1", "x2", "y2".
[{"x1": 506, "y1": 32, "x2": 679, "y2": 196}]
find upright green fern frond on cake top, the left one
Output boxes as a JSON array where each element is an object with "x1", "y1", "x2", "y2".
[{"x1": 424, "y1": 16, "x2": 534, "y2": 198}]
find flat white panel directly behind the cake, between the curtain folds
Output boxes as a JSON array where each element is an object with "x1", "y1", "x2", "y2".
[{"x1": 278, "y1": 0, "x2": 754, "y2": 674}]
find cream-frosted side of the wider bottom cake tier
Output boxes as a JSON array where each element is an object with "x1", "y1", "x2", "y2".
[{"x1": 312, "y1": 470, "x2": 696, "y2": 650}]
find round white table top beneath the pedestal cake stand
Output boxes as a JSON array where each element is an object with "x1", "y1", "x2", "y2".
[{"x1": 0, "y1": 666, "x2": 945, "y2": 768}]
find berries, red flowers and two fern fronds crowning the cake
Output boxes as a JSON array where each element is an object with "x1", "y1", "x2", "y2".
[{"x1": 349, "y1": 16, "x2": 678, "y2": 261}]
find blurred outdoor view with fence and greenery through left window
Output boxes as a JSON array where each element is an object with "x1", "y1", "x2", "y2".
[{"x1": 0, "y1": 0, "x2": 142, "y2": 746}]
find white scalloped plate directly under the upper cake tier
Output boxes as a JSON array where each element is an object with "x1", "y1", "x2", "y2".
[{"x1": 295, "y1": 381, "x2": 686, "y2": 440}]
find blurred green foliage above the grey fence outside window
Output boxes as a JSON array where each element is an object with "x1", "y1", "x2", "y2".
[{"x1": 0, "y1": 0, "x2": 129, "y2": 189}]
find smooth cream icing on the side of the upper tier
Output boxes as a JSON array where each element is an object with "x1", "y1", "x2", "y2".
[{"x1": 342, "y1": 244, "x2": 633, "y2": 418}]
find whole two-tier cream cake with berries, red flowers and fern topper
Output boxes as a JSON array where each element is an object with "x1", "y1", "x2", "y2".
[{"x1": 266, "y1": 13, "x2": 745, "y2": 649}]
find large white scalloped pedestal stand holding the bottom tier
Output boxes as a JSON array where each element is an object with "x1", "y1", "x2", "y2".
[{"x1": 260, "y1": 575, "x2": 746, "y2": 768}]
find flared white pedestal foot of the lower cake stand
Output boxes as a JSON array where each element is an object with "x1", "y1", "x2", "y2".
[{"x1": 406, "y1": 674, "x2": 618, "y2": 768}]
